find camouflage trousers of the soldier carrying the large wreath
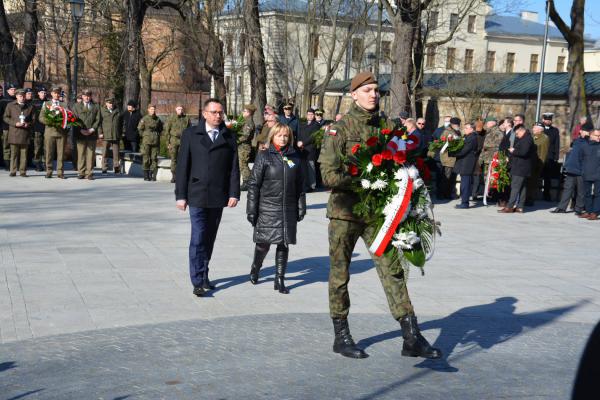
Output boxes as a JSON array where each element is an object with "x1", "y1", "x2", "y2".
[{"x1": 329, "y1": 219, "x2": 414, "y2": 319}]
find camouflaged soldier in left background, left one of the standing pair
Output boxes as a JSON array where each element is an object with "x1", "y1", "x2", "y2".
[{"x1": 138, "y1": 104, "x2": 163, "y2": 181}]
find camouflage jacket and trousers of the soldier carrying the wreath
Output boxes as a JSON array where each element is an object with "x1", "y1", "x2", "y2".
[{"x1": 319, "y1": 101, "x2": 414, "y2": 319}]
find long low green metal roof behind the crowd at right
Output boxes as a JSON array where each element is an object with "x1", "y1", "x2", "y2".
[{"x1": 327, "y1": 72, "x2": 600, "y2": 98}]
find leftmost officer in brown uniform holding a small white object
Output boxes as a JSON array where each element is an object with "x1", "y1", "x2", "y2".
[{"x1": 3, "y1": 89, "x2": 33, "y2": 177}]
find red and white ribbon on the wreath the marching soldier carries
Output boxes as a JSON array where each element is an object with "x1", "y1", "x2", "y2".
[{"x1": 369, "y1": 168, "x2": 413, "y2": 257}]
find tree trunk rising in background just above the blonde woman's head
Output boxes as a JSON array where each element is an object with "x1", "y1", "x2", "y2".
[{"x1": 242, "y1": 0, "x2": 267, "y2": 122}]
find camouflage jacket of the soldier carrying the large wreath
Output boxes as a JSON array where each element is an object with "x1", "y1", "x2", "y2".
[{"x1": 319, "y1": 104, "x2": 394, "y2": 222}]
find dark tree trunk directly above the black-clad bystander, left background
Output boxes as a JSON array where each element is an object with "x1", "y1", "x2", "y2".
[{"x1": 123, "y1": 0, "x2": 146, "y2": 108}]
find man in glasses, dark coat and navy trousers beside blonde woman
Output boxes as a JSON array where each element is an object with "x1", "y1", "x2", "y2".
[{"x1": 175, "y1": 99, "x2": 240, "y2": 297}]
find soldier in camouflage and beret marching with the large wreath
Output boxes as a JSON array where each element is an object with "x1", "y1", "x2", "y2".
[{"x1": 319, "y1": 72, "x2": 441, "y2": 358}]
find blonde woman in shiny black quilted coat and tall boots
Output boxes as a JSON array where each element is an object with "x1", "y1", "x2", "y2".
[{"x1": 246, "y1": 123, "x2": 306, "y2": 293}]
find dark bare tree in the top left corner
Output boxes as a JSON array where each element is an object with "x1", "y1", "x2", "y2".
[{"x1": 0, "y1": 0, "x2": 39, "y2": 86}]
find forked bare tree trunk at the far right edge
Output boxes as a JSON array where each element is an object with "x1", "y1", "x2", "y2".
[{"x1": 548, "y1": 0, "x2": 588, "y2": 131}]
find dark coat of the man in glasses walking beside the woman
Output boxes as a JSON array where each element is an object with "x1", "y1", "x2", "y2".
[{"x1": 175, "y1": 121, "x2": 240, "y2": 208}]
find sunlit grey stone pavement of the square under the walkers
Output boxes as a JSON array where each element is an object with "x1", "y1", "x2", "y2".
[{"x1": 0, "y1": 166, "x2": 600, "y2": 399}]
